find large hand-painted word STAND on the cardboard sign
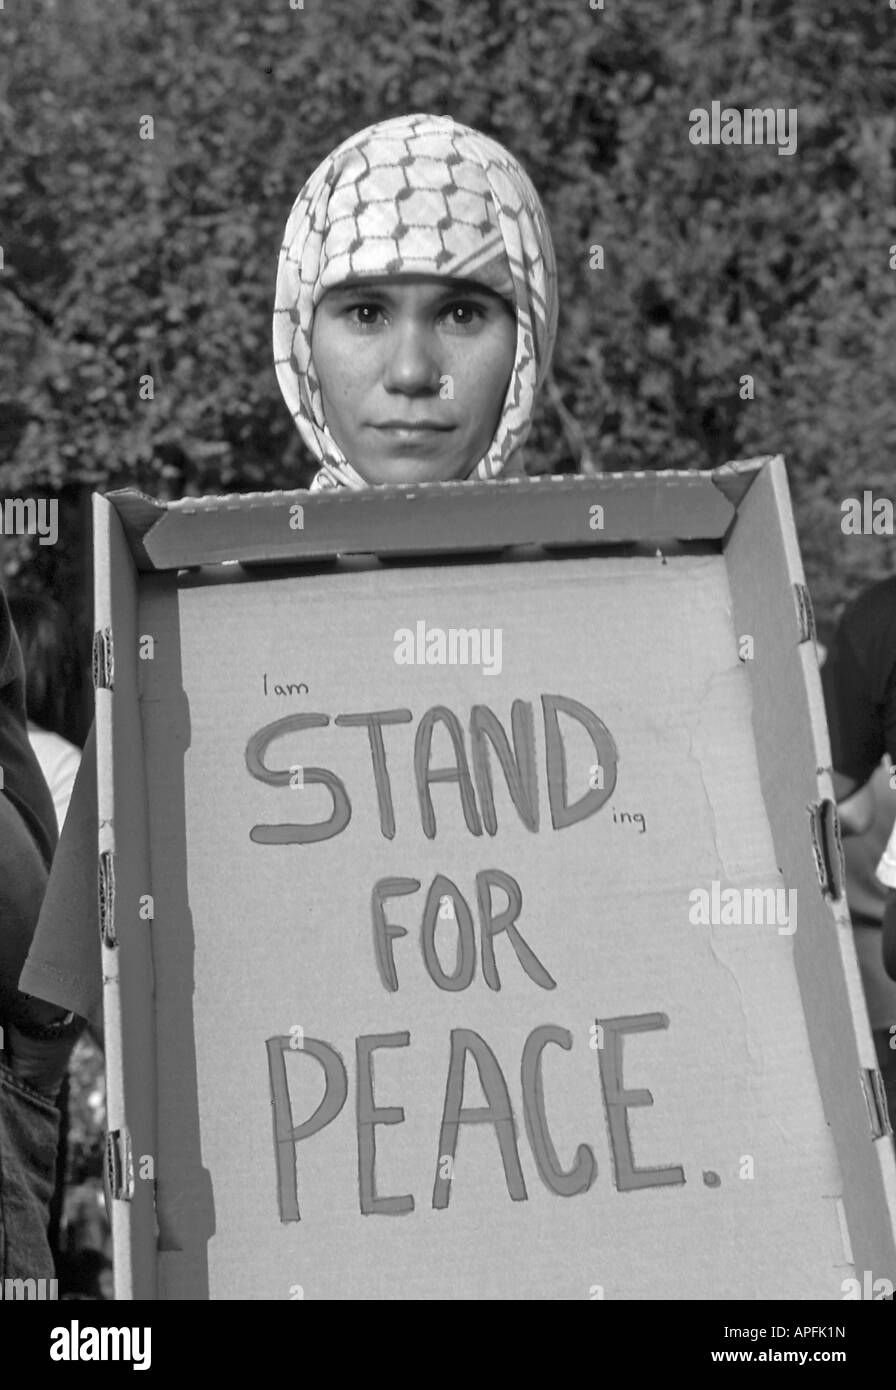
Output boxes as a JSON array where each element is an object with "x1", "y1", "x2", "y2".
[{"x1": 246, "y1": 695, "x2": 618, "y2": 845}]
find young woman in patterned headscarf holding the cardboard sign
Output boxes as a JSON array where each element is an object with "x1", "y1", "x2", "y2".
[{"x1": 8, "y1": 115, "x2": 557, "y2": 1284}]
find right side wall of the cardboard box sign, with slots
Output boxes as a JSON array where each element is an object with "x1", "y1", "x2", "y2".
[{"x1": 725, "y1": 457, "x2": 896, "y2": 1282}]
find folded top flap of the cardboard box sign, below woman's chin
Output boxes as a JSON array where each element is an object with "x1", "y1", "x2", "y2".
[{"x1": 108, "y1": 460, "x2": 739, "y2": 570}]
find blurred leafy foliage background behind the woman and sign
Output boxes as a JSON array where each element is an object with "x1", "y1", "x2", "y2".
[{"x1": 0, "y1": 0, "x2": 896, "y2": 1297}]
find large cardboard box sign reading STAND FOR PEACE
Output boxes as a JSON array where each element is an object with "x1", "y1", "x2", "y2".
[{"x1": 97, "y1": 463, "x2": 896, "y2": 1298}]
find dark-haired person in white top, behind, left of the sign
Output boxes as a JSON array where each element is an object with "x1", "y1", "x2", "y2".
[{"x1": 10, "y1": 594, "x2": 81, "y2": 830}]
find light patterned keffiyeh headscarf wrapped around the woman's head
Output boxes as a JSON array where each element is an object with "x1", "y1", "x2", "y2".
[{"x1": 274, "y1": 115, "x2": 557, "y2": 491}]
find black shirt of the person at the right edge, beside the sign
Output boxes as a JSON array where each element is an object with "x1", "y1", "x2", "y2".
[{"x1": 821, "y1": 577, "x2": 896, "y2": 785}]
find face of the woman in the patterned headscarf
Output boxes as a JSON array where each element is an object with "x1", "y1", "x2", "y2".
[{"x1": 311, "y1": 275, "x2": 517, "y2": 484}]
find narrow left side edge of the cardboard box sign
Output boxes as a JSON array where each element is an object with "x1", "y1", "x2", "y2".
[{"x1": 93, "y1": 496, "x2": 157, "y2": 1298}]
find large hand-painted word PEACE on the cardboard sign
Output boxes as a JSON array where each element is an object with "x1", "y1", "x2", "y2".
[{"x1": 267, "y1": 1013, "x2": 685, "y2": 1222}]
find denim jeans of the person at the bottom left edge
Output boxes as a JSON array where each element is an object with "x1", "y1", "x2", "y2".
[{"x1": 0, "y1": 1052, "x2": 60, "y2": 1279}]
